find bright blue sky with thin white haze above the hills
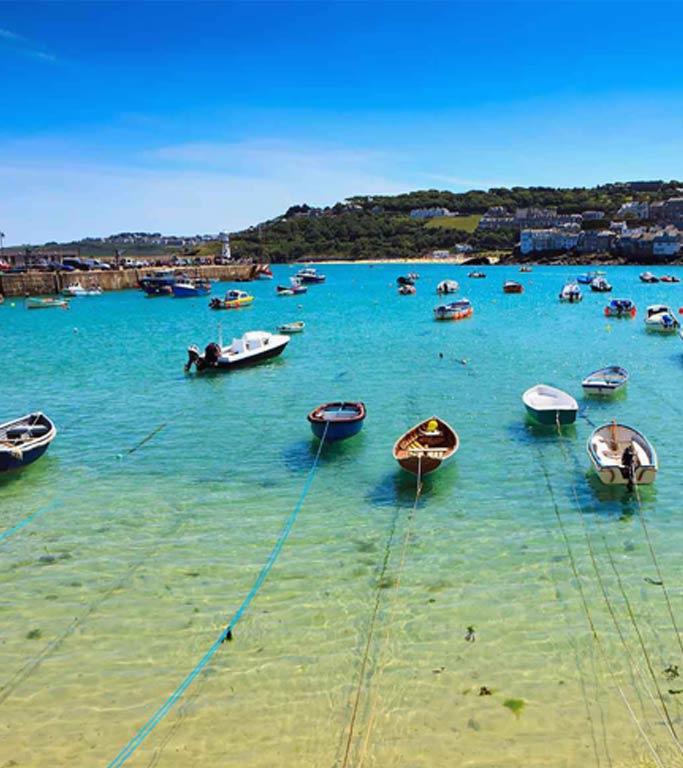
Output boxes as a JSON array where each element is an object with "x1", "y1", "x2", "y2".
[{"x1": 0, "y1": 0, "x2": 683, "y2": 244}]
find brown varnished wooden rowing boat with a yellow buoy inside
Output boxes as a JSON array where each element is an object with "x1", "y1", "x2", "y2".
[{"x1": 394, "y1": 416, "x2": 460, "y2": 476}]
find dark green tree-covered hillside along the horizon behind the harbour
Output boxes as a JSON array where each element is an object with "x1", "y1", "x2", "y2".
[{"x1": 13, "y1": 181, "x2": 682, "y2": 263}]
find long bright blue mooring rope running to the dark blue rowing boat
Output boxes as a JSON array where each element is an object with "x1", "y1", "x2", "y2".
[{"x1": 107, "y1": 421, "x2": 330, "y2": 768}]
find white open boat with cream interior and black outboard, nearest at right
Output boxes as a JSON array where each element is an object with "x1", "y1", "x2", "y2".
[{"x1": 586, "y1": 421, "x2": 658, "y2": 487}]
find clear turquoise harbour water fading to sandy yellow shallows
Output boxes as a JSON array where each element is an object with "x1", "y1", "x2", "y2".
[{"x1": 0, "y1": 265, "x2": 683, "y2": 768}]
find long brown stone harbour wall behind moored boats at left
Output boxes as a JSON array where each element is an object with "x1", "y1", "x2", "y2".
[{"x1": 0, "y1": 264, "x2": 259, "y2": 296}]
